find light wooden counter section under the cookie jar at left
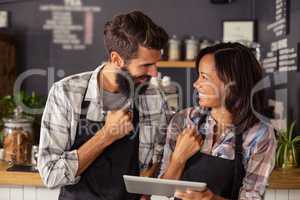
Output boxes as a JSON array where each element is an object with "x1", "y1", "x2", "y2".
[{"x1": 0, "y1": 161, "x2": 44, "y2": 187}]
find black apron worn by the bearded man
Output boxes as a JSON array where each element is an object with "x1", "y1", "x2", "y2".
[{"x1": 59, "y1": 81, "x2": 139, "y2": 200}]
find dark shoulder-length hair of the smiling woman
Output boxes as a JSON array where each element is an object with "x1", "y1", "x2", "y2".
[{"x1": 196, "y1": 43, "x2": 264, "y2": 132}]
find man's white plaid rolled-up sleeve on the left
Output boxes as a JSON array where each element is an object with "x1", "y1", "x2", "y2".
[{"x1": 38, "y1": 84, "x2": 80, "y2": 188}]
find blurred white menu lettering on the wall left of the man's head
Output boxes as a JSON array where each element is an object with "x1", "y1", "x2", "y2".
[{"x1": 40, "y1": 0, "x2": 101, "y2": 50}]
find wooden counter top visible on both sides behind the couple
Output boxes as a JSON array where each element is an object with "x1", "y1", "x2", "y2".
[{"x1": 0, "y1": 161, "x2": 300, "y2": 189}]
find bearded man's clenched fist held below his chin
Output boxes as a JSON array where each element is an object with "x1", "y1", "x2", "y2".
[{"x1": 103, "y1": 110, "x2": 133, "y2": 142}]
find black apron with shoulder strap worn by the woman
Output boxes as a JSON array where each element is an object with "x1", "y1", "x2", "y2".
[{"x1": 177, "y1": 122, "x2": 245, "y2": 200}]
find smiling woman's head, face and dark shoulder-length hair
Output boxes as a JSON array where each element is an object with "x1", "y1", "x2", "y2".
[{"x1": 194, "y1": 43, "x2": 264, "y2": 131}]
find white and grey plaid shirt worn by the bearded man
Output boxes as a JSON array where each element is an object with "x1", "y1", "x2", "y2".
[{"x1": 38, "y1": 65, "x2": 167, "y2": 187}]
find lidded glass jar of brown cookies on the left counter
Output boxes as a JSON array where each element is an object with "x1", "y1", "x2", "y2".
[{"x1": 3, "y1": 107, "x2": 34, "y2": 165}]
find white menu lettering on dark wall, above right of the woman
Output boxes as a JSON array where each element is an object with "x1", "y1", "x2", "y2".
[{"x1": 262, "y1": 0, "x2": 297, "y2": 72}]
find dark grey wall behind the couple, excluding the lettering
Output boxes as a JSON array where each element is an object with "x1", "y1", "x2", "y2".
[{"x1": 0, "y1": 0, "x2": 300, "y2": 130}]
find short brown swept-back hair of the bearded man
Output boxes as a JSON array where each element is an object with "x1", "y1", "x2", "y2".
[{"x1": 104, "y1": 11, "x2": 168, "y2": 61}]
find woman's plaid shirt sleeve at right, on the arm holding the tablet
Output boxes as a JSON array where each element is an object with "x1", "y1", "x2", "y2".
[{"x1": 239, "y1": 126, "x2": 277, "y2": 200}]
